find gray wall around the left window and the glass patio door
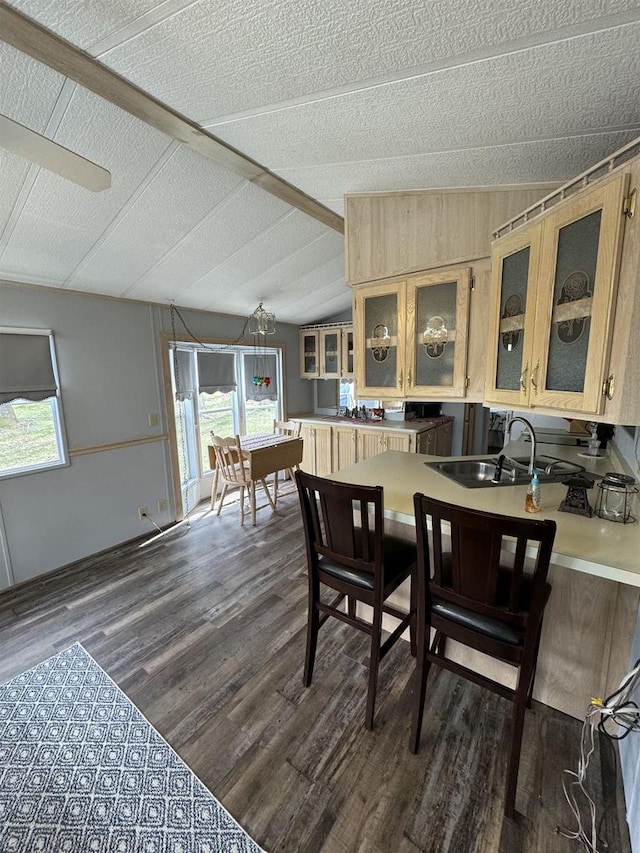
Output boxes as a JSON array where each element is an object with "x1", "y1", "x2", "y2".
[{"x1": 0, "y1": 283, "x2": 311, "y2": 589}]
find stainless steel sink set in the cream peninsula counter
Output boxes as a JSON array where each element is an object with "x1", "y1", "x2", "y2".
[{"x1": 424, "y1": 456, "x2": 584, "y2": 489}]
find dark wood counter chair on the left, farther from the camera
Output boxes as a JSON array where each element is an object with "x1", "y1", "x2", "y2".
[{"x1": 295, "y1": 471, "x2": 416, "y2": 729}]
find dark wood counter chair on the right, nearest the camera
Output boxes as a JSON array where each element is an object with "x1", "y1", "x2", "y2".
[{"x1": 409, "y1": 493, "x2": 556, "y2": 817}]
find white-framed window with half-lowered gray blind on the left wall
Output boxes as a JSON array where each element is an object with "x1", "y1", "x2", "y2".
[{"x1": 0, "y1": 327, "x2": 67, "y2": 477}]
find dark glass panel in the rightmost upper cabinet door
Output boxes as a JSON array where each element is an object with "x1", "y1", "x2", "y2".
[{"x1": 545, "y1": 210, "x2": 602, "y2": 393}]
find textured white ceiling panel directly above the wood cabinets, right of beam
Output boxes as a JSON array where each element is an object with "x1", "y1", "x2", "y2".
[{"x1": 281, "y1": 130, "x2": 640, "y2": 198}]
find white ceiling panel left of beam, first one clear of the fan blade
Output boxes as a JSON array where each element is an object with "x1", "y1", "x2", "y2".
[{"x1": 66, "y1": 143, "x2": 242, "y2": 295}]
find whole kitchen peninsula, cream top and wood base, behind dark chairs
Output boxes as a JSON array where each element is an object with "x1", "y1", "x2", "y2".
[{"x1": 332, "y1": 445, "x2": 640, "y2": 719}]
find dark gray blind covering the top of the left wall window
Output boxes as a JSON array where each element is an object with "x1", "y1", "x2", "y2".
[{"x1": 0, "y1": 332, "x2": 58, "y2": 403}]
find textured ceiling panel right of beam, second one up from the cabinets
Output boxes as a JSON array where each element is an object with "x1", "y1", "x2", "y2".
[{"x1": 211, "y1": 24, "x2": 640, "y2": 171}]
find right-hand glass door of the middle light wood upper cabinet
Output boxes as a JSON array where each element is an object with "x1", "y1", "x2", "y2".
[{"x1": 406, "y1": 268, "x2": 471, "y2": 398}]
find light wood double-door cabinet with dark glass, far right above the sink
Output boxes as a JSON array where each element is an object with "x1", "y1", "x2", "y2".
[{"x1": 485, "y1": 173, "x2": 628, "y2": 414}]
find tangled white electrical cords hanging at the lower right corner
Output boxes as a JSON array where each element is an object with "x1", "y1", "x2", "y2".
[{"x1": 558, "y1": 658, "x2": 640, "y2": 853}]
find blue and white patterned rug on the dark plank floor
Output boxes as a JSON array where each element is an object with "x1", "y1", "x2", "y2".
[{"x1": 0, "y1": 643, "x2": 261, "y2": 853}]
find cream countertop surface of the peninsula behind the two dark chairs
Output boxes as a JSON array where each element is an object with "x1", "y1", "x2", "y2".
[{"x1": 331, "y1": 444, "x2": 640, "y2": 587}]
